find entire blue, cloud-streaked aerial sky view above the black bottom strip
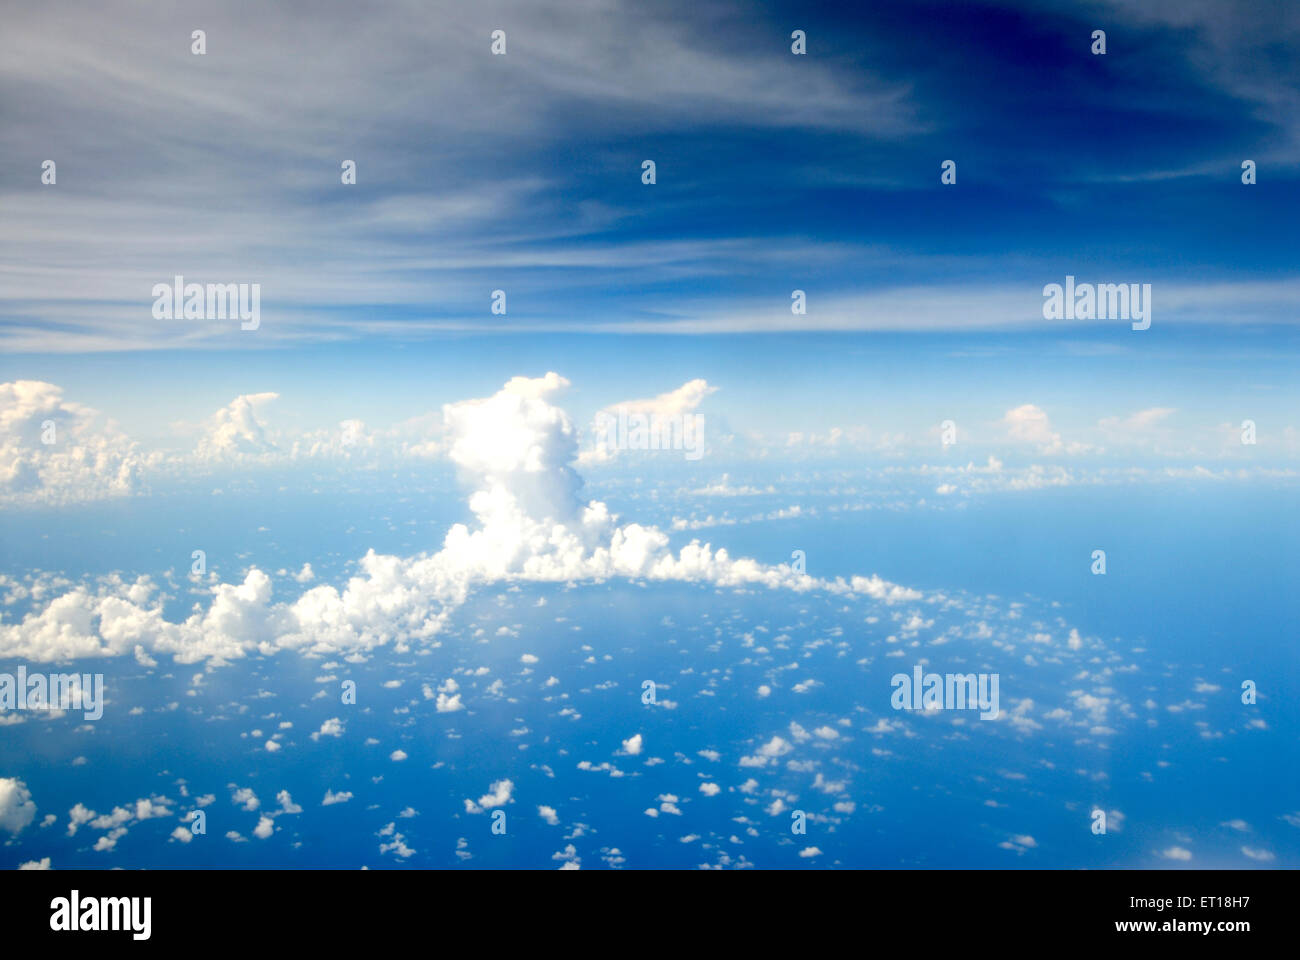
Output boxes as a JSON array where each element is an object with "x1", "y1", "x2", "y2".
[{"x1": 0, "y1": 0, "x2": 1300, "y2": 869}]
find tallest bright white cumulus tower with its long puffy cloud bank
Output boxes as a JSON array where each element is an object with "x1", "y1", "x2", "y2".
[{"x1": 0, "y1": 373, "x2": 920, "y2": 662}]
